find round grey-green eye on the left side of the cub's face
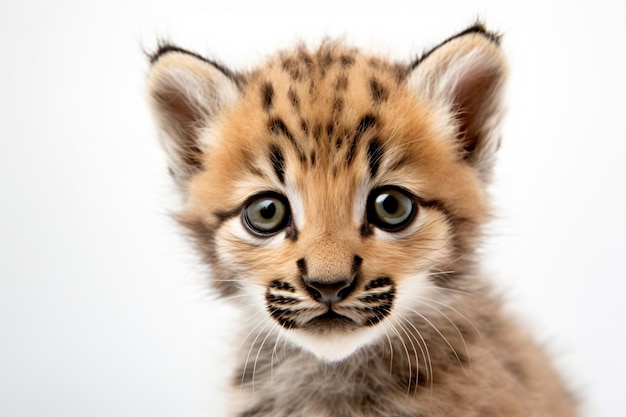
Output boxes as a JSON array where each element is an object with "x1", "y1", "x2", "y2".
[{"x1": 243, "y1": 194, "x2": 289, "y2": 236}]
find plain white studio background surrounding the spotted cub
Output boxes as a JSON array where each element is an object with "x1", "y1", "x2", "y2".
[{"x1": 0, "y1": 0, "x2": 626, "y2": 417}]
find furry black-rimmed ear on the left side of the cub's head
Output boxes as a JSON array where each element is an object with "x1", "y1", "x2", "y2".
[{"x1": 148, "y1": 45, "x2": 239, "y2": 185}]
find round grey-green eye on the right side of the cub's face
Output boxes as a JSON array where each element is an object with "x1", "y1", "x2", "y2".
[{"x1": 367, "y1": 187, "x2": 417, "y2": 231}]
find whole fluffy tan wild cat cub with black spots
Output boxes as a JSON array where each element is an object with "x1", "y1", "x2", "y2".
[{"x1": 149, "y1": 25, "x2": 575, "y2": 417}]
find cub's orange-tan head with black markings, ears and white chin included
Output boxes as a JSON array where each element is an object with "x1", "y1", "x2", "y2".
[{"x1": 149, "y1": 25, "x2": 506, "y2": 361}]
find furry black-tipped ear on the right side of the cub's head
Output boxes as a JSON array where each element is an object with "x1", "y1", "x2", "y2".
[{"x1": 409, "y1": 24, "x2": 507, "y2": 181}]
